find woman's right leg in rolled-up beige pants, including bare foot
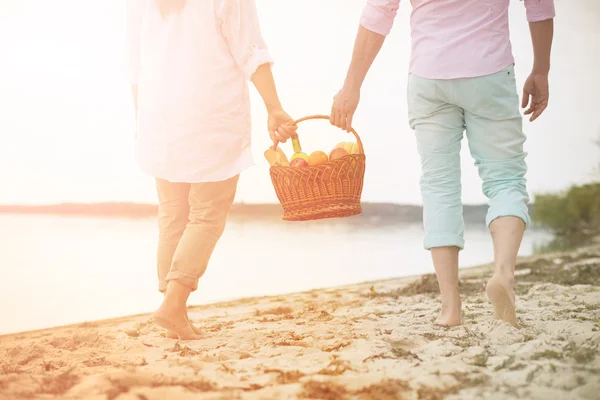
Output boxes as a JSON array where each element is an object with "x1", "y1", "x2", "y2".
[{"x1": 154, "y1": 176, "x2": 238, "y2": 340}]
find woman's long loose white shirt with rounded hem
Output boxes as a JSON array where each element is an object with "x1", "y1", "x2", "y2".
[{"x1": 127, "y1": 0, "x2": 272, "y2": 182}]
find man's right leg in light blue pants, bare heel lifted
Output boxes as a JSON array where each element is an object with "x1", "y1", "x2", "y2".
[{"x1": 460, "y1": 66, "x2": 530, "y2": 326}]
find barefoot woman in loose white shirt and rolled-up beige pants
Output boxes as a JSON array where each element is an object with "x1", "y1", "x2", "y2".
[{"x1": 127, "y1": 0, "x2": 296, "y2": 340}]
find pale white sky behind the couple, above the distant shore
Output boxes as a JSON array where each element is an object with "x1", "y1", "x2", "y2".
[{"x1": 0, "y1": 0, "x2": 600, "y2": 204}]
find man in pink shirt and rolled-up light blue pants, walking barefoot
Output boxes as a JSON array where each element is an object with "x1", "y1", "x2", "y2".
[{"x1": 330, "y1": 0, "x2": 554, "y2": 326}]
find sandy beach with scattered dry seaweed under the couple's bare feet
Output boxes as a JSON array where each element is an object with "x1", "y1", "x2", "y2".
[{"x1": 0, "y1": 246, "x2": 600, "y2": 400}]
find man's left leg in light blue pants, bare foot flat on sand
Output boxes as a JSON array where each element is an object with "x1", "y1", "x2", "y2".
[{"x1": 409, "y1": 75, "x2": 464, "y2": 326}]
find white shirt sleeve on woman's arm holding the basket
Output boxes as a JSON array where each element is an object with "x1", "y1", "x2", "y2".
[{"x1": 221, "y1": 0, "x2": 273, "y2": 80}]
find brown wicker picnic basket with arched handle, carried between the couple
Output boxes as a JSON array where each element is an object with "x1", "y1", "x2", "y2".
[{"x1": 270, "y1": 115, "x2": 365, "y2": 221}]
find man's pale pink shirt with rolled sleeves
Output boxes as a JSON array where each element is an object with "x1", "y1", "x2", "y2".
[{"x1": 360, "y1": 0, "x2": 555, "y2": 79}]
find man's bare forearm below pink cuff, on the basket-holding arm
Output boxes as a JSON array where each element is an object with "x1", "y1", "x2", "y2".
[{"x1": 344, "y1": 26, "x2": 385, "y2": 90}]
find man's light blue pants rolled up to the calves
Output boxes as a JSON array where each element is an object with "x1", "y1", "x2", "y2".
[{"x1": 408, "y1": 65, "x2": 530, "y2": 249}]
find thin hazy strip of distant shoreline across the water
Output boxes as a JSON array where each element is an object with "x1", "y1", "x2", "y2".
[{"x1": 0, "y1": 202, "x2": 536, "y2": 225}]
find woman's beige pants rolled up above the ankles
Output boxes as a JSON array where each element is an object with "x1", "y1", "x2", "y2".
[{"x1": 156, "y1": 175, "x2": 239, "y2": 292}]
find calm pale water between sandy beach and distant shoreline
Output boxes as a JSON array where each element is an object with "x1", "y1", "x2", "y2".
[{"x1": 0, "y1": 215, "x2": 550, "y2": 334}]
